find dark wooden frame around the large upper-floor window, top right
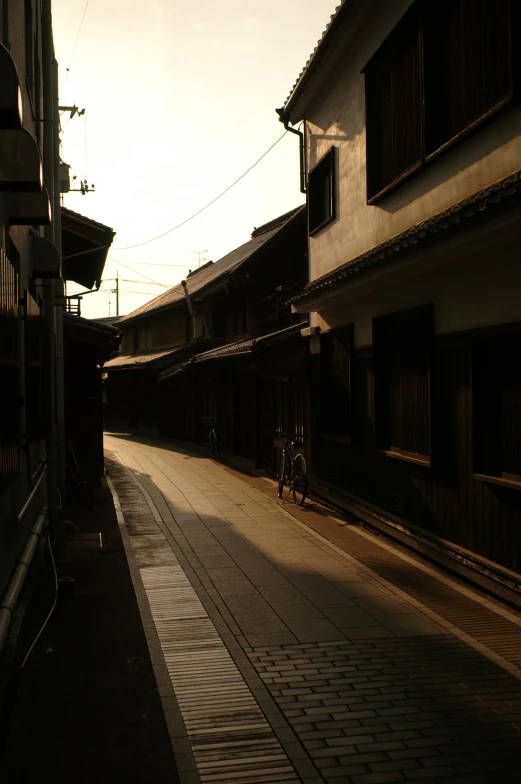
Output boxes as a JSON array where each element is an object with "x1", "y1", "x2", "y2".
[{"x1": 362, "y1": 0, "x2": 521, "y2": 205}]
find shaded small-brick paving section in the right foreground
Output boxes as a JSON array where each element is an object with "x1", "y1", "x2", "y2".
[{"x1": 248, "y1": 636, "x2": 521, "y2": 784}]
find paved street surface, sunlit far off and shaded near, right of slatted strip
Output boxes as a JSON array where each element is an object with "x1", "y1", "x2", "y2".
[{"x1": 106, "y1": 439, "x2": 521, "y2": 784}]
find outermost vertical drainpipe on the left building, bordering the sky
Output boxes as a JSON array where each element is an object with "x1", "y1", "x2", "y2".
[{"x1": 52, "y1": 59, "x2": 66, "y2": 506}]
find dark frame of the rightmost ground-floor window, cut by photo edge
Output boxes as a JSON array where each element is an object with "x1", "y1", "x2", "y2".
[{"x1": 470, "y1": 322, "x2": 521, "y2": 490}]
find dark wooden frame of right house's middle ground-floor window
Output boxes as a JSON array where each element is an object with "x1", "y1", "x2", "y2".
[{"x1": 373, "y1": 303, "x2": 435, "y2": 467}]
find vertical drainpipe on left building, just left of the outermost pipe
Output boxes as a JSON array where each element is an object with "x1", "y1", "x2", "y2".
[{"x1": 42, "y1": 0, "x2": 65, "y2": 554}]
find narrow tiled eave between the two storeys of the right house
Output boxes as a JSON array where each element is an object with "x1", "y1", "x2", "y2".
[{"x1": 288, "y1": 169, "x2": 521, "y2": 305}]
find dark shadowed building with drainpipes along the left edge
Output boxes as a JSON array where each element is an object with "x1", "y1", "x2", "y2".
[{"x1": 0, "y1": 0, "x2": 117, "y2": 700}]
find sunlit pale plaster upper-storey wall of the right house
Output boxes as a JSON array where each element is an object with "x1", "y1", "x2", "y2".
[{"x1": 292, "y1": 0, "x2": 521, "y2": 281}]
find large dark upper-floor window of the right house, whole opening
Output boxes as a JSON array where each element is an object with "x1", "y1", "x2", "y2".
[{"x1": 364, "y1": 0, "x2": 520, "y2": 202}]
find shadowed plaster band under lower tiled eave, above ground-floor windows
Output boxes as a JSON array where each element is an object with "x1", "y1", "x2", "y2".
[{"x1": 314, "y1": 243, "x2": 521, "y2": 347}]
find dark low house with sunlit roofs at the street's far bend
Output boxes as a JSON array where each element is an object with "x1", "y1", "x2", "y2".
[{"x1": 104, "y1": 207, "x2": 307, "y2": 472}]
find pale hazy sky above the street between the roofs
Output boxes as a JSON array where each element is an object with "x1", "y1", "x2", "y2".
[{"x1": 53, "y1": 0, "x2": 335, "y2": 318}]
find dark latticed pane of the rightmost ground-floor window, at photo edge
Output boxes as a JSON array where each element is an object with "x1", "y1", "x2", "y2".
[{"x1": 472, "y1": 331, "x2": 521, "y2": 485}]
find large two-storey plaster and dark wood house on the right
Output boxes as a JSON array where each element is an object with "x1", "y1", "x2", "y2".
[{"x1": 278, "y1": 0, "x2": 521, "y2": 590}]
